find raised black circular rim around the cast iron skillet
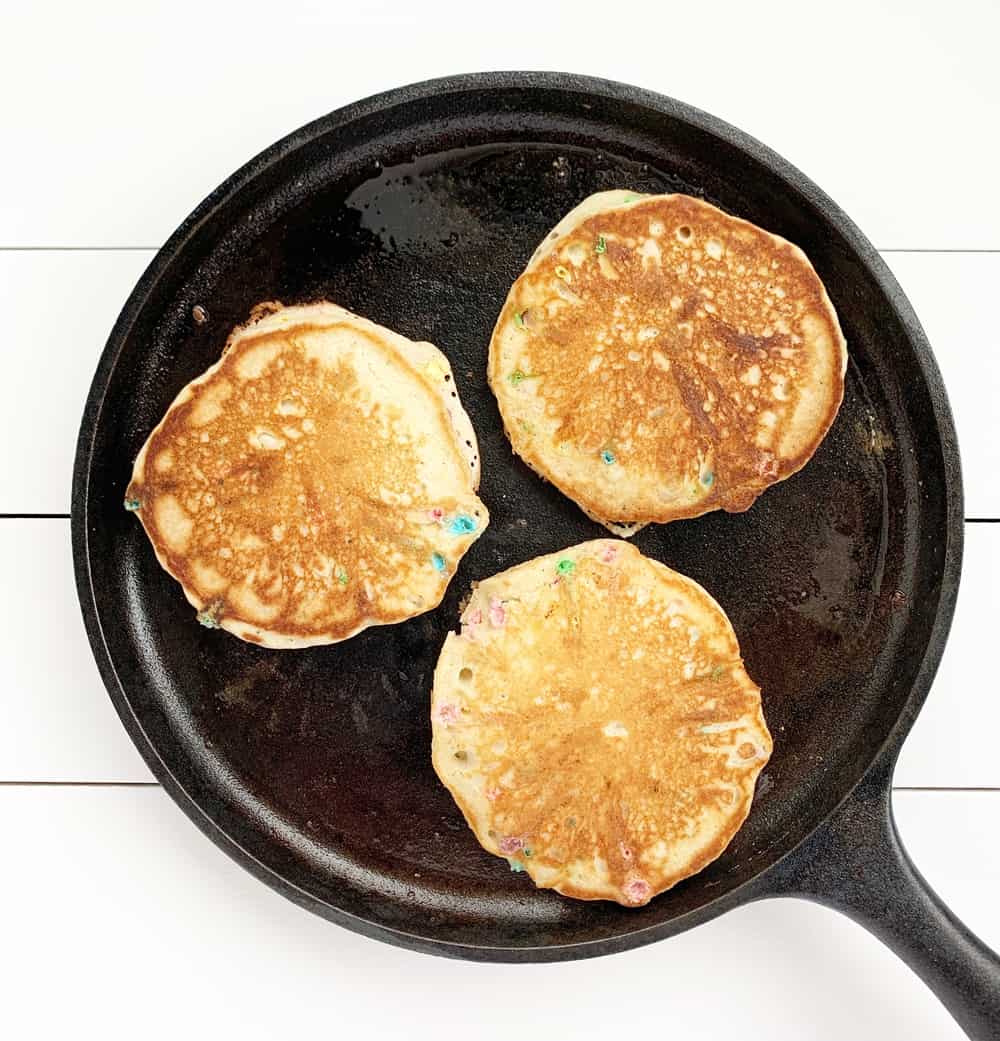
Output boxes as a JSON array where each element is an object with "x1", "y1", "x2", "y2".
[{"x1": 71, "y1": 72, "x2": 965, "y2": 962}]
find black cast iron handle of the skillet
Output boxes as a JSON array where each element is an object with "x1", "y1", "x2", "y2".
[{"x1": 769, "y1": 764, "x2": 1000, "y2": 1041}]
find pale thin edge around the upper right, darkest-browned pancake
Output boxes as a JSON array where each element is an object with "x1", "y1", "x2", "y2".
[{"x1": 489, "y1": 188, "x2": 848, "y2": 538}]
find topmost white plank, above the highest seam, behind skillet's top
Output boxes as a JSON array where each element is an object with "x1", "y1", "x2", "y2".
[{"x1": 0, "y1": 0, "x2": 1000, "y2": 249}]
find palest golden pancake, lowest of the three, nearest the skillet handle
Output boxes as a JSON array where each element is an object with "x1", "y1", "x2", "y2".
[{"x1": 431, "y1": 539, "x2": 771, "y2": 907}]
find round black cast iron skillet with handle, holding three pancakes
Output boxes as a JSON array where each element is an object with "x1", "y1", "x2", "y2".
[{"x1": 73, "y1": 73, "x2": 1000, "y2": 1038}]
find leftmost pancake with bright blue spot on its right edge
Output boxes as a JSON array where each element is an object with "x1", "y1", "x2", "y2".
[{"x1": 125, "y1": 303, "x2": 488, "y2": 649}]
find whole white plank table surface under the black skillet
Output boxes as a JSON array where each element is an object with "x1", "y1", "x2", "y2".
[{"x1": 0, "y1": 0, "x2": 1000, "y2": 1041}]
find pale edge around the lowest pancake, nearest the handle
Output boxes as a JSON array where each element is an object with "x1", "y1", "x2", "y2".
[{"x1": 430, "y1": 539, "x2": 773, "y2": 907}]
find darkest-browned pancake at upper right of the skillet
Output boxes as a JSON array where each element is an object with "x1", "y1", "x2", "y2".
[{"x1": 489, "y1": 192, "x2": 847, "y2": 535}]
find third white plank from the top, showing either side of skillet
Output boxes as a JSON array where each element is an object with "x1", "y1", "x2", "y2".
[{"x1": 0, "y1": 519, "x2": 1000, "y2": 787}]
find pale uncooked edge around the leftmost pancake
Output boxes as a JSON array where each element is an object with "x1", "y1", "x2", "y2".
[{"x1": 131, "y1": 301, "x2": 489, "y2": 651}]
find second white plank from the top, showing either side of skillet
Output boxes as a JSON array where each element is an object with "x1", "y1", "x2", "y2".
[{"x1": 0, "y1": 251, "x2": 1000, "y2": 517}]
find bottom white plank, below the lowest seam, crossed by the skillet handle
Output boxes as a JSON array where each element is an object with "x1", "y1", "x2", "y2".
[{"x1": 0, "y1": 788, "x2": 1000, "y2": 1041}]
